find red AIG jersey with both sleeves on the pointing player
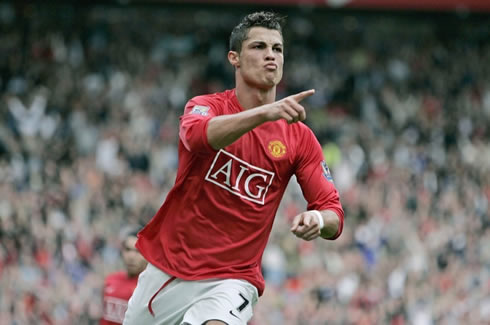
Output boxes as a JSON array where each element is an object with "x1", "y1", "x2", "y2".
[{"x1": 136, "y1": 90, "x2": 344, "y2": 295}]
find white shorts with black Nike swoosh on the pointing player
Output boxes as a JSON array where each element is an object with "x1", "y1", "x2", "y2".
[{"x1": 123, "y1": 263, "x2": 258, "y2": 325}]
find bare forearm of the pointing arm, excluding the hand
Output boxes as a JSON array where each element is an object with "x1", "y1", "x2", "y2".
[{"x1": 206, "y1": 106, "x2": 267, "y2": 150}]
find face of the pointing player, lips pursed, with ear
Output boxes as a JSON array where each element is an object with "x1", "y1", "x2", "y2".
[{"x1": 228, "y1": 27, "x2": 284, "y2": 89}]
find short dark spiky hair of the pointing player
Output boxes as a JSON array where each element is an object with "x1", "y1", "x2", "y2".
[{"x1": 230, "y1": 11, "x2": 286, "y2": 52}]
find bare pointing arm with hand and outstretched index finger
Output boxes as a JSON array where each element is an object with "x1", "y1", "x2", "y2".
[{"x1": 206, "y1": 89, "x2": 315, "y2": 150}]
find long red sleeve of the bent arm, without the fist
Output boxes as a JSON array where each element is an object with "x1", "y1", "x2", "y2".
[{"x1": 295, "y1": 129, "x2": 344, "y2": 240}]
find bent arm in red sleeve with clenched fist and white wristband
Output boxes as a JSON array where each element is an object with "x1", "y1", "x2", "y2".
[{"x1": 291, "y1": 129, "x2": 344, "y2": 240}]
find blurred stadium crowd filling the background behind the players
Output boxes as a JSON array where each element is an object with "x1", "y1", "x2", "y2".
[{"x1": 0, "y1": 0, "x2": 490, "y2": 325}]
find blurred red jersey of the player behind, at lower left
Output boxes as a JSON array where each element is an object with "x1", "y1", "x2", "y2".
[{"x1": 100, "y1": 271, "x2": 138, "y2": 325}]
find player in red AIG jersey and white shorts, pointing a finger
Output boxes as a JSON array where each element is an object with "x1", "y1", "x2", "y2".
[{"x1": 124, "y1": 12, "x2": 343, "y2": 325}]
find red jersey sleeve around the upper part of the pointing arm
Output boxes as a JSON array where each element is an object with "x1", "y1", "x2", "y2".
[{"x1": 179, "y1": 96, "x2": 219, "y2": 153}]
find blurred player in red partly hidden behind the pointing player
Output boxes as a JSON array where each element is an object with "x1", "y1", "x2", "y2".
[{"x1": 100, "y1": 230, "x2": 147, "y2": 325}]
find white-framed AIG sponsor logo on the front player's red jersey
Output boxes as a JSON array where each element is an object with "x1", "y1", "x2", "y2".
[{"x1": 205, "y1": 150, "x2": 274, "y2": 205}]
